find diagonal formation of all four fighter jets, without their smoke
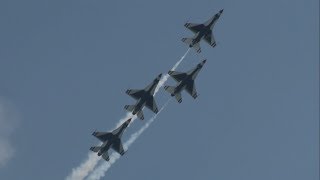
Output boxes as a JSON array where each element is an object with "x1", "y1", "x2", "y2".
[{"x1": 90, "y1": 9, "x2": 223, "y2": 161}]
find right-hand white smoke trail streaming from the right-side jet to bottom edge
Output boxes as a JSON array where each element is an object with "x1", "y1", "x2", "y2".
[{"x1": 87, "y1": 98, "x2": 171, "y2": 180}]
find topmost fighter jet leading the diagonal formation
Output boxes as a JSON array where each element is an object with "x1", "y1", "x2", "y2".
[{"x1": 182, "y1": 9, "x2": 223, "y2": 53}]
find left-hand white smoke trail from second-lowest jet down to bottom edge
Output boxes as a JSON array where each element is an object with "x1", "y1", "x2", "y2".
[{"x1": 65, "y1": 112, "x2": 137, "y2": 180}]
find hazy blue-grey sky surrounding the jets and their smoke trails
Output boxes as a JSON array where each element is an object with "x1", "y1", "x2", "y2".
[{"x1": 0, "y1": 0, "x2": 319, "y2": 180}]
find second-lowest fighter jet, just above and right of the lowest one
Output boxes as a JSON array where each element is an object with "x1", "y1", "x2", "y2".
[{"x1": 124, "y1": 74, "x2": 162, "y2": 120}]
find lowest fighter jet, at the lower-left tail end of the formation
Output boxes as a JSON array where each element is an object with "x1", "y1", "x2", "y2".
[{"x1": 90, "y1": 118, "x2": 131, "y2": 161}]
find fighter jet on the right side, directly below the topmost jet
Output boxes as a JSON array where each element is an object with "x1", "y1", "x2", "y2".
[{"x1": 164, "y1": 60, "x2": 206, "y2": 103}]
